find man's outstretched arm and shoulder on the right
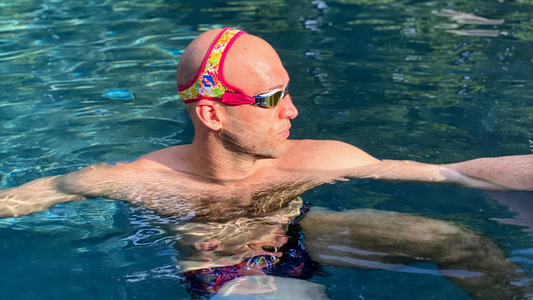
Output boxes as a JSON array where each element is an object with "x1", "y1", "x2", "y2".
[{"x1": 286, "y1": 140, "x2": 533, "y2": 191}]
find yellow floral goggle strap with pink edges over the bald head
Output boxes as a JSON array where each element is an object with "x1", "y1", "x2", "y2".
[{"x1": 178, "y1": 28, "x2": 245, "y2": 103}]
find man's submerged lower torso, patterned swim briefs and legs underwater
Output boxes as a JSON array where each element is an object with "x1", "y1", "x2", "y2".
[{"x1": 172, "y1": 203, "x2": 529, "y2": 299}]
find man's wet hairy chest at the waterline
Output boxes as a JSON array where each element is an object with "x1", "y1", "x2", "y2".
[{"x1": 115, "y1": 171, "x2": 317, "y2": 221}]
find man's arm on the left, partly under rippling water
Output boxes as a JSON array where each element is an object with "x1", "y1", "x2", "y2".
[{"x1": 0, "y1": 164, "x2": 120, "y2": 218}]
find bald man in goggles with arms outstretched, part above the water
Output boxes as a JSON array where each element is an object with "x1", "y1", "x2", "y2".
[{"x1": 0, "y1": 28, "x2": 533, "y2": 298}]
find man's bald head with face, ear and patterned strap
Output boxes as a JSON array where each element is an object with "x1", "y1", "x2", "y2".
[{"x1": 177, "y1": 30, "x2": 298, "y2": 162}]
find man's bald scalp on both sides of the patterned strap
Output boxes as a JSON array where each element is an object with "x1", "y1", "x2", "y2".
[{"x1": 177, "y1": 29, "x2": 288, "y2": 95}]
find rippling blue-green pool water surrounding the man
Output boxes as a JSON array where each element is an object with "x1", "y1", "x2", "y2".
[{"x1": 0, "y1": 0, "x2": 533, "y2": 299}]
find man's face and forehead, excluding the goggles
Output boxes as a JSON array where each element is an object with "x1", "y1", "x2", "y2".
[{"x1": 220, "y1": 35, "x2": 298, "y2": 158}]
